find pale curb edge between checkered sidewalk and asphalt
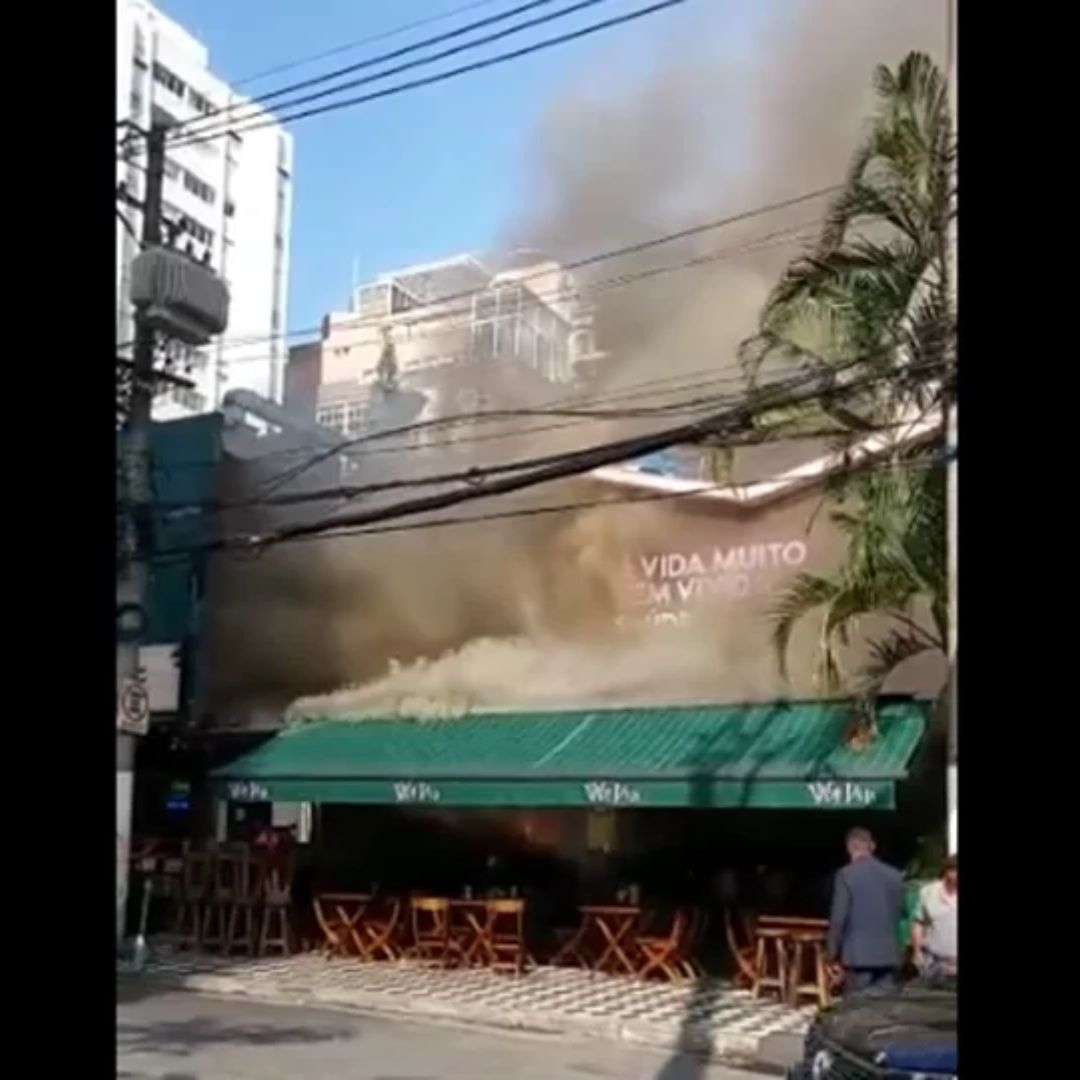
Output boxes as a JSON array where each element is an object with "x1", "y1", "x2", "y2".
[{"x1": 121, "y1": 972, "x2": 790, "y2": 1071}]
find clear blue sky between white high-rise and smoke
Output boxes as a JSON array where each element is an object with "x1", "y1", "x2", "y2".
[{"x1": 158, "y1": 0, "x2": 755, "y2": 332}]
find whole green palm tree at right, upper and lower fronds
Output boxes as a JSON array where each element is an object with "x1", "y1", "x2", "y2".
[{"x1": 743, "y1": 53, "x2": 955, "y2": 718}]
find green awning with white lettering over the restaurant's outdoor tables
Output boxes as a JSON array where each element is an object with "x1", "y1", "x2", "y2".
[{"x1": 214, "y1": 702, "x2": 927, "y2": 810}]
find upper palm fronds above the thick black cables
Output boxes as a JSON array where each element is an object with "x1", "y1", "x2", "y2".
[{"x1": 743, "y1": 53, "x2": 955, "y2": 431}]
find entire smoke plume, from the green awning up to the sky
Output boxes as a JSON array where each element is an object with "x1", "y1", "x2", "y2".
[{"x1": 204, "y1": 0, "x2": 945, "y2": 718}]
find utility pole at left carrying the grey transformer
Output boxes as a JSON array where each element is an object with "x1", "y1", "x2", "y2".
[{"x1": 116, "y1": 126, "x2": 165, "y2": 944}]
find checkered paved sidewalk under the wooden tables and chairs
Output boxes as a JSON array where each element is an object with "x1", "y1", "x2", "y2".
[{"x1": 124, "y1": 946, "x2": 813, "y2": 1063}]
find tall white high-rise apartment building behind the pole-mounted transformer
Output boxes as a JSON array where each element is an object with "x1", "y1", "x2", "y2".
[{"x1": 117, "y1": 0, "x2": 293, "y2": 419}]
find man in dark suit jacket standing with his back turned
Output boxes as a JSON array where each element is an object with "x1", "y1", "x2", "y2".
[{"x1": 827, "y1": 828, "x2": 904, "y2": 993}]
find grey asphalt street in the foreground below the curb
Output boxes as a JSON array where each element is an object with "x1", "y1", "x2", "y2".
[{"x1": 117, "y1": 986, "x2": 768, "y2": 1080}]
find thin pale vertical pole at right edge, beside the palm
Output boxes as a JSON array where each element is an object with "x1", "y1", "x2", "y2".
[{"x1": 945, "y1": 0, "x2": 960, "y2": 854}]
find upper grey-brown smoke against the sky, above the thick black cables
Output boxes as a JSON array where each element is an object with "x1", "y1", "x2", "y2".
[{"x1": 510, "y1": 0, "x2": 945, "y2": 395}]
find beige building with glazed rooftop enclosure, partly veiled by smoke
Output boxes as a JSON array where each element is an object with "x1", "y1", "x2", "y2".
[{"x1": 316, "y1": 252, "x2": 594, "y2": 435}]
